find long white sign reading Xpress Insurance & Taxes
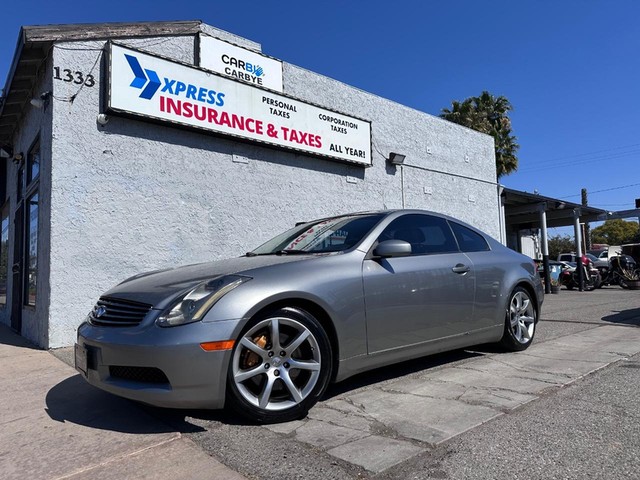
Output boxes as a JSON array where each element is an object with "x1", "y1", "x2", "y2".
[{"x1": 107, "y1": 43, "x2": 371, "y2": 165}]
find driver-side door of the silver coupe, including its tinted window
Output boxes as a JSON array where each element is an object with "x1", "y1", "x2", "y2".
[{"x1": 363, "y1": 214, "x2": 475, "y2": 353}]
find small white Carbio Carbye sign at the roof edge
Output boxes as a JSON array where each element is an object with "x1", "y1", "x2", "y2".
[{"x1": 199, "y1": 34, "x2": 283, "y2": 92}]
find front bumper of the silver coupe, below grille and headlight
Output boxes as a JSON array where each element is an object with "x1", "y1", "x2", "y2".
[{"x1": 76, "y1": 320, "x2": 240, "y2": 409}]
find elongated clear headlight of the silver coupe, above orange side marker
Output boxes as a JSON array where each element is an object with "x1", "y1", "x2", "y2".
[{"x1": 156, "y1": 275, "x2": 251, "y2": 327}]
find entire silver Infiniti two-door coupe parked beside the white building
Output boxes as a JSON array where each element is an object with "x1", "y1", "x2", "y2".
[{"x1": 75, "y1": 210, "x2": 544, "y2": 422}]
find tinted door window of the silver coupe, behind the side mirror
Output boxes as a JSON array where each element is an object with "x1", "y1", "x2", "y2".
[{"x1": 378, "y1": 214, "x2": 458, "y2": 255}]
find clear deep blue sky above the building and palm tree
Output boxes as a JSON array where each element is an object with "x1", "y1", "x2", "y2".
[{"x1": 0, "y1": 0, "x2": 640, "y2": 232}]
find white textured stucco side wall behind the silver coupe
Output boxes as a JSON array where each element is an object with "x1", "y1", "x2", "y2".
[{"x1": 43, "y1": 29, "x2": 499, "y2": 347}]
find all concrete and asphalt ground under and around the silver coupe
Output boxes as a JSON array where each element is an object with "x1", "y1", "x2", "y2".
[{"x1": 0, "y1": 287, "x2": 640, "y2": 479}]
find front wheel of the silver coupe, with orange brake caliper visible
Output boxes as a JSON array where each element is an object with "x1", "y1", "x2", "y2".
[{"x1": 226, "y1": 308, "x2": 333, "y2": 423}]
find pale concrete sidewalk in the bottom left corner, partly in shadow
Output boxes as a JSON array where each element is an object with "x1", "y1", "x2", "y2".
[{"x1": 0, "y1": 325, "x2": 244, "y2": 480}]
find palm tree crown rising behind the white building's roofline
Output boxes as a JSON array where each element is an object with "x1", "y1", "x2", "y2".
[{"x1": 440, "y1": 91, "x2": 520, "y2": 178}]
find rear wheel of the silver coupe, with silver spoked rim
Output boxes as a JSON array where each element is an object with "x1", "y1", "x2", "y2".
[{"x1": 500, "y1": 287, "x2": 538, "y2": 352}]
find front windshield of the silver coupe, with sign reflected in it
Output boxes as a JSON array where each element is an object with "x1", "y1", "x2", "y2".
[{"x1": 247, "y1": 214, "x2": 384, "y2": 256}]
